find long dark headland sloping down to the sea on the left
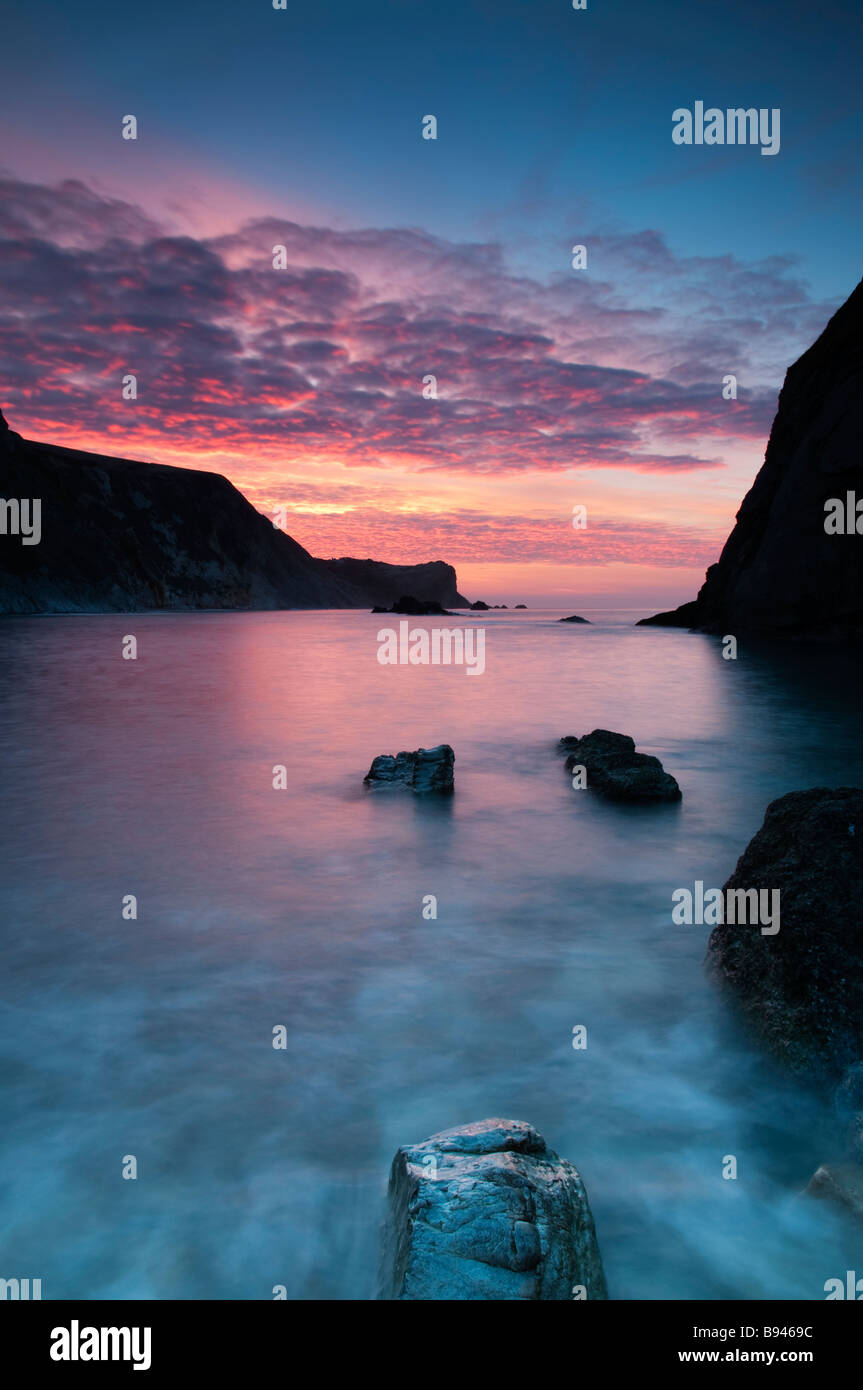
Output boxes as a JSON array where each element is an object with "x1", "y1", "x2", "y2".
[{"x1": 0, "y1": 414, "x2": 466, "y2": 613}]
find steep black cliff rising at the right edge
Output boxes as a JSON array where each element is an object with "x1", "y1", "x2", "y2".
[{"x1": 641, "y1": 281, "x2": 863, "y2": 641}]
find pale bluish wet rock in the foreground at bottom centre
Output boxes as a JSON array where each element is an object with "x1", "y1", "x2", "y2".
[{"x1": 381, "y1": 1119, "x2": 609, "y2": 1301}]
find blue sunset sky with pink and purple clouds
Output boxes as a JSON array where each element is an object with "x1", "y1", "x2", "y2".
[{"x1": 0, "y1": 0, "x2": 863, "y2": 610}]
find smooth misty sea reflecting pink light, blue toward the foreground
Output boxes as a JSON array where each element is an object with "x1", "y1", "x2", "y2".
[{"x1": 0, "y1": 610, "x2": 863, "y2": 1300}]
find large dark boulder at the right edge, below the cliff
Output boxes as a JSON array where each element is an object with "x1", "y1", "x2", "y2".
[{"x1": 707, "y1": 787, "x2": 863, "y2": 1077}]
